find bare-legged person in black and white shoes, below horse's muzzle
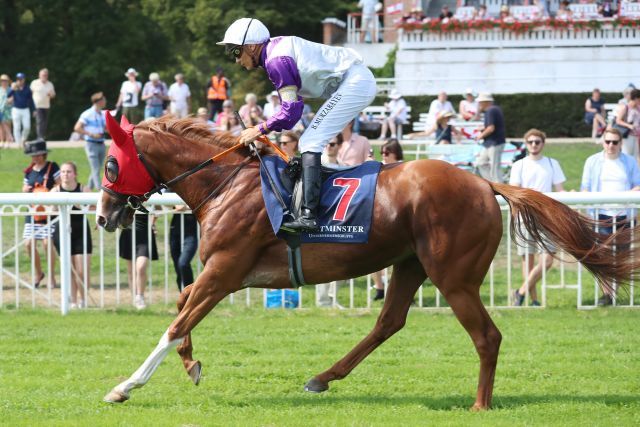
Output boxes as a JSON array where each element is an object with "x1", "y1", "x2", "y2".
[{"x1": 118, "y1": 213, "x2": 158, "y2": 310}]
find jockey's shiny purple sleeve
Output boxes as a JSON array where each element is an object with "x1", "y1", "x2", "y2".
[{"x1": 261, "y1": 56, "x2": 304, "y2": 132}]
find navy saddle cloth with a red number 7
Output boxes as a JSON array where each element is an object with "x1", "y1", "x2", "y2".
[{"x1": 260, "y1": 156, "x2": 382, "y2": 243}]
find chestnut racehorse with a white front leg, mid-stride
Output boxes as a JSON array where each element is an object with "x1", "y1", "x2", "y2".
[{"x1": 98, "y1": 116, "x2": 640, "y2": 409}]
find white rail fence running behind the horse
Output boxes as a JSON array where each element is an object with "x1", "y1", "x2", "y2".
[{"x1": 0, "y1": 192, "x2": 640, "y2": 314}]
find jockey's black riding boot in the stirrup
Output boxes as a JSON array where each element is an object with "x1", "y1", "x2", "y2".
[{"x1": 282, "y1": 153, "x2": 322, "y2": 232}]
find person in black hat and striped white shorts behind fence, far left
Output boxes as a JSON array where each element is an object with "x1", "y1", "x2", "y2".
[{"x1": 22, "y1": 139, "x2": 60, "y2": 288}]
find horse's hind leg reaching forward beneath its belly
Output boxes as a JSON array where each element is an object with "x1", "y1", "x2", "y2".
[{"x1": 304, "y1": 257, "x2": 426, "y2": 393}]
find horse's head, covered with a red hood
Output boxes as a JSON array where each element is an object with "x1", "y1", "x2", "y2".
[{"x1": 96, "y1": 111, "x2": 154, "y2": 232}]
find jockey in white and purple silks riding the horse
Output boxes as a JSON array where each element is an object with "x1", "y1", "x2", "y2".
[{"x1": 218, "y1": 18, "x2": 376, "y2": 232}]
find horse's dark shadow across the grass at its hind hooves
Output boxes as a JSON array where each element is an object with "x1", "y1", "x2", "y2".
[{"x1": 236, "y1": 394, "x2": 640, "y2": 411}]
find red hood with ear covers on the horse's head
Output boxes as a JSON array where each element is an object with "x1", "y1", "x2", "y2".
[{"x1": 102, "y1": 110, "x2": 154, "y2": 196}]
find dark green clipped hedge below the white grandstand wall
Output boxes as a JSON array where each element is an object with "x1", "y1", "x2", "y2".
[{"x1": 372, "y1": 92, "x2": 622, "y2": 138}]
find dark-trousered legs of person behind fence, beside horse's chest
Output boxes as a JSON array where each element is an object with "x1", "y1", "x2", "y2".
[{"x1": 169, "y1": 206, "x2": 199, "y2": 292}]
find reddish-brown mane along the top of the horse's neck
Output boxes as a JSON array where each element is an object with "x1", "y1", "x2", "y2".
[{"x1": 136, "y1": 114, "x2": 238, "y2": 148}]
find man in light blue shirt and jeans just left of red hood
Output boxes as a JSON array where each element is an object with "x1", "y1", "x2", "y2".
[{"x1": 73, "y1": 92, "x2": 107, "y2": 190}]
